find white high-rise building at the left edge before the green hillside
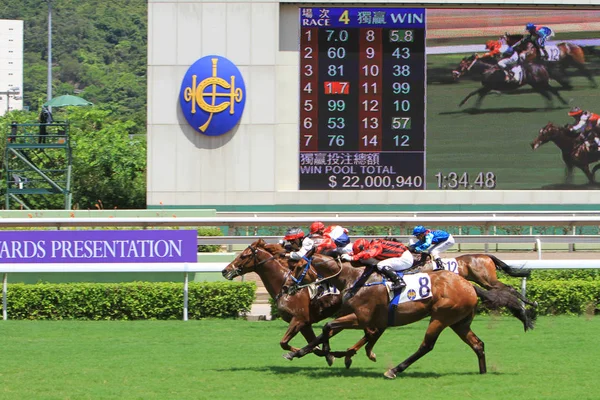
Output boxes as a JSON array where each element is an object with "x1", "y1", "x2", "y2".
[{"x1": 0, "y1": 19, "x2": 23, "y2": 115}]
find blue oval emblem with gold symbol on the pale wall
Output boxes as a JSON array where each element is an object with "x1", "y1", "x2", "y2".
[{"x1": 179, "y1": 56, "x2": 246, "y2": 136}]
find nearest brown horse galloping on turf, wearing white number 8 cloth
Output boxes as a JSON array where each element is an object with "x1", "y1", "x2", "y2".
[{"x1": 286, "y1": 255, "x2": 533, "y2": 379}]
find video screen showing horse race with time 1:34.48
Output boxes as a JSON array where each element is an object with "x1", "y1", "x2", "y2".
[{"x1": 426, "y1": 8, "x2": 600, "y2": 190}]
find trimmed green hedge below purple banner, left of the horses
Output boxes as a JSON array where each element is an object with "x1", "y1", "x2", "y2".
[{"x1": 7, "y1": 282, "x2": 256, "y2": 320}]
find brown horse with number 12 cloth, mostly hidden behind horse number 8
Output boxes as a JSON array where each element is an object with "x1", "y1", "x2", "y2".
[{"x1": 410, "y1": 254, "x2": 537, "y2": 307}]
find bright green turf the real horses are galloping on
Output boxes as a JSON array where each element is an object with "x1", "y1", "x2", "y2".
[{"x1": 0, "y1": 316, "x2": 600, "y2": 400}]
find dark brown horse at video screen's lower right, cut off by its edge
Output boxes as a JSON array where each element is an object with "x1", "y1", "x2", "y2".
[{"x1": 531, "y1": 122, "x2": 600, "y2": 183}]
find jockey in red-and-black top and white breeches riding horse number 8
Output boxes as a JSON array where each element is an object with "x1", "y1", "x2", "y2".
[{"x1": 342, "y1": 239, "x2": 413, "y2": 291}]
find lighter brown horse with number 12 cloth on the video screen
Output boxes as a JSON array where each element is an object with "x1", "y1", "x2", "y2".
[{"x1": 501, "y1": 33, "x2": 598, "y2": 87}]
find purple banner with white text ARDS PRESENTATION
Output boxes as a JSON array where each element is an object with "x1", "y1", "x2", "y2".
[{"x1": 0, "y1": 230, "x2": 198, "y2": 264}]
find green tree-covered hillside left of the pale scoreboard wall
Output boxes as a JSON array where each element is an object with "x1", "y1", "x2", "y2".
[{"x1": 0, "y1": 0, "x2": 147, "y2": 209}]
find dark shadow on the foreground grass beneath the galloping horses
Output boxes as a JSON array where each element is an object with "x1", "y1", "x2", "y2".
[{"x1": 213, "y1": 365, "x2": 508, "y2": 379}]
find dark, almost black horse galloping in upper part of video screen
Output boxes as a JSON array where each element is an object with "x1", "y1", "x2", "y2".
[{"x1": 452, "y1": 55, "x2": 567, "y2": 107}]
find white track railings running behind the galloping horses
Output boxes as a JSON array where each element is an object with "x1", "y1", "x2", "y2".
[{"x1": 0, "y1": 212, "x2": 600, "y2": 320}]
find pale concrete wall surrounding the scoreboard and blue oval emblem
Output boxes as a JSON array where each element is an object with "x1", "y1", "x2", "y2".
[{"x1": 148, "y1": 0, "x2": 600, "y2": 205}]
